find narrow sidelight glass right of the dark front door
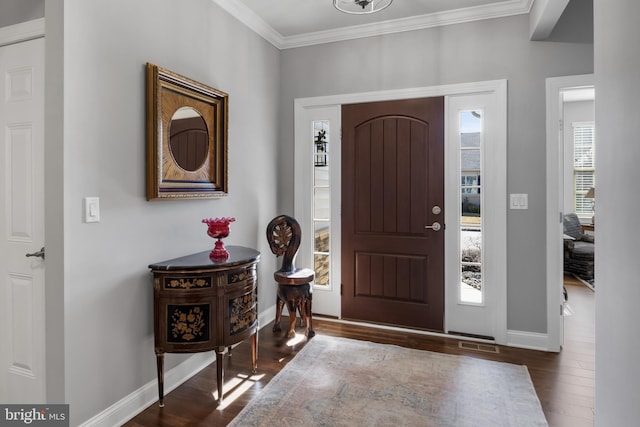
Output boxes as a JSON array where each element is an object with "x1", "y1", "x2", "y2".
[{"x1": 459, "y1": 110, "x2": 484, "y2": 304}]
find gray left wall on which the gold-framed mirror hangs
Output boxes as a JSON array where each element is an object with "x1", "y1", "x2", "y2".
[{"x1": 46, "y1": 0, "x2": 280, "y2": 425}]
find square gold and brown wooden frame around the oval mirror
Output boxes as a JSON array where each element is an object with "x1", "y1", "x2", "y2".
[{"x1": 146, "y1": 63, "x2": 229, "y2": 200}]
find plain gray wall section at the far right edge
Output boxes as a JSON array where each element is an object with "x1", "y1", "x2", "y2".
[{"x1": 594, "y1": 0, "x2": 640, "y2": 427}]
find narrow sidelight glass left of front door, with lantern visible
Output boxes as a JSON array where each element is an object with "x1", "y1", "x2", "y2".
[{"x1": 310, "y1": 120, "x2": 331, "y2": 287}]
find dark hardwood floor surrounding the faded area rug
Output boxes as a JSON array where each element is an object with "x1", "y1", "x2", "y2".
[{"x1": 125, "y1": 278, "x2": 595, "y2": 427}]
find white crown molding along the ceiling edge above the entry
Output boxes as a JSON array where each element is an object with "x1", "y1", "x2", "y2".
[{"x1": 212, "y1": 0, "x2": 535, "y2": 50}]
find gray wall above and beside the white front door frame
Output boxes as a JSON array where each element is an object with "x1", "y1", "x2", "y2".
[{"x1": 279, "y1": 15, "x2": 593, "y2": 333}]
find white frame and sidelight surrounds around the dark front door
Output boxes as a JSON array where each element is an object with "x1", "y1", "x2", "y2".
[{"x1": 294, "y1": 80, "x2": 507, "y2": 344}]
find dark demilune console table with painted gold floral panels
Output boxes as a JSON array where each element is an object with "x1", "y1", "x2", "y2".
[{"x1": 149, "y1": 246, "x2": 260, "y2": 407}]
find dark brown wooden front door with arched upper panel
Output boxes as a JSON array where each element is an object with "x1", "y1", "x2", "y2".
[{"x1": 342, "y1": 97, "x2": 444, "y2": 331}]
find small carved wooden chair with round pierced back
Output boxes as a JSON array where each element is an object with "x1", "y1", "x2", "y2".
[{"x1": 267, "y1": 215, "x2": 315, "y2": 338}]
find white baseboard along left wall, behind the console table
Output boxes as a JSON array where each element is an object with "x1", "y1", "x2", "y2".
[{"x1": 80, "y1": 306, "x2": 276, "y2": 427}]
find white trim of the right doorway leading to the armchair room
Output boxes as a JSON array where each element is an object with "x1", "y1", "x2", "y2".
[{"x1": 546, "y1": 74, "x2": 594, "y2": 352}]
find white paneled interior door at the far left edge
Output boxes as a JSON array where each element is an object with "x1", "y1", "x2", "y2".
[{"x1": 0, "y1": 38, "x2": 45, "y2": 403}]
